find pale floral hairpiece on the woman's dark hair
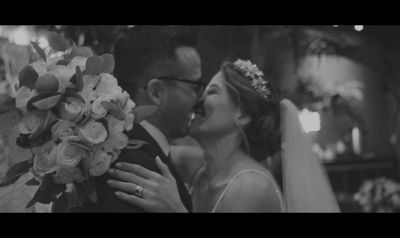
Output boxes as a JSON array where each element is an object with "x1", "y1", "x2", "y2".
[{"x1": 233, "y1": 59, "x2": 271, "y2": 99}]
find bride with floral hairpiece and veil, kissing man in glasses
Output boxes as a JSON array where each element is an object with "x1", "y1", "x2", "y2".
[{"x1": 105, "y1": 60, "x2": 339, "y2": 212}]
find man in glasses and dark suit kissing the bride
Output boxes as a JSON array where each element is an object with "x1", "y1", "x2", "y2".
[{"x1": 87, "y1": 26, "x2": 204, "y2": 212}]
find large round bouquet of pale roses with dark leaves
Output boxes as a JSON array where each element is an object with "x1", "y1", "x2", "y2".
[{"x1": 0, "y1": 33, "x2": 141, "y2": 210}]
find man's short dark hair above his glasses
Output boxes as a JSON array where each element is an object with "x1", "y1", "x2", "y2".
[{"x1": 114, "y1": 26, "x2": 195, "y2": 96}]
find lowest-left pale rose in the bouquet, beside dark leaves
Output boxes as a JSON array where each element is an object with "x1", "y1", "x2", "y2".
[{"x1": 32, "y1": 142, "x2": 58, "y2": 176}]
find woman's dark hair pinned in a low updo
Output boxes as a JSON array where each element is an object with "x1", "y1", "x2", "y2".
[{"x1": 221, "y1": 61, "x2": 281, "y2": 161}]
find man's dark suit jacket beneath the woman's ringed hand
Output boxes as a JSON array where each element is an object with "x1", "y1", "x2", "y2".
[{"x1": 84, "y1": 123, "x2": 192, "y2": 212}]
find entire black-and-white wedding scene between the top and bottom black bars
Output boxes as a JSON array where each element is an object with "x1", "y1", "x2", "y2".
[{"x1": 0, "y1": 25, "x2": 400, "y2": 213}]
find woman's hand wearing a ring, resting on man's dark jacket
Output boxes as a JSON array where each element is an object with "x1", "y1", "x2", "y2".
[{"x1": 107, "y1": 156, "x2": 187, "y2": 212}]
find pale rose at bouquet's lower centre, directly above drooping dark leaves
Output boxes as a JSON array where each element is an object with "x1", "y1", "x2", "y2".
[{"x1": 57, "y1": 141, "x2": 86, "y2": 168}]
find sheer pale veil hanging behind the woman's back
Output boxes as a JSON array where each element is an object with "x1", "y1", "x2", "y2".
[{"x1": 281, "y1": 99, "x2": 340, "y2": 212}]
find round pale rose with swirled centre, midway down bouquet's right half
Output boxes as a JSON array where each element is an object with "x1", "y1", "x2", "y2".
[{"x1": 79, "y1": 121, "x2": 108, "y2": 144}]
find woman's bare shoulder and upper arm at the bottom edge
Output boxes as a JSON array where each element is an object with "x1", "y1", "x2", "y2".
[{"x1": 217, "y1": 173, "x2": 282, "y2": 212}]
